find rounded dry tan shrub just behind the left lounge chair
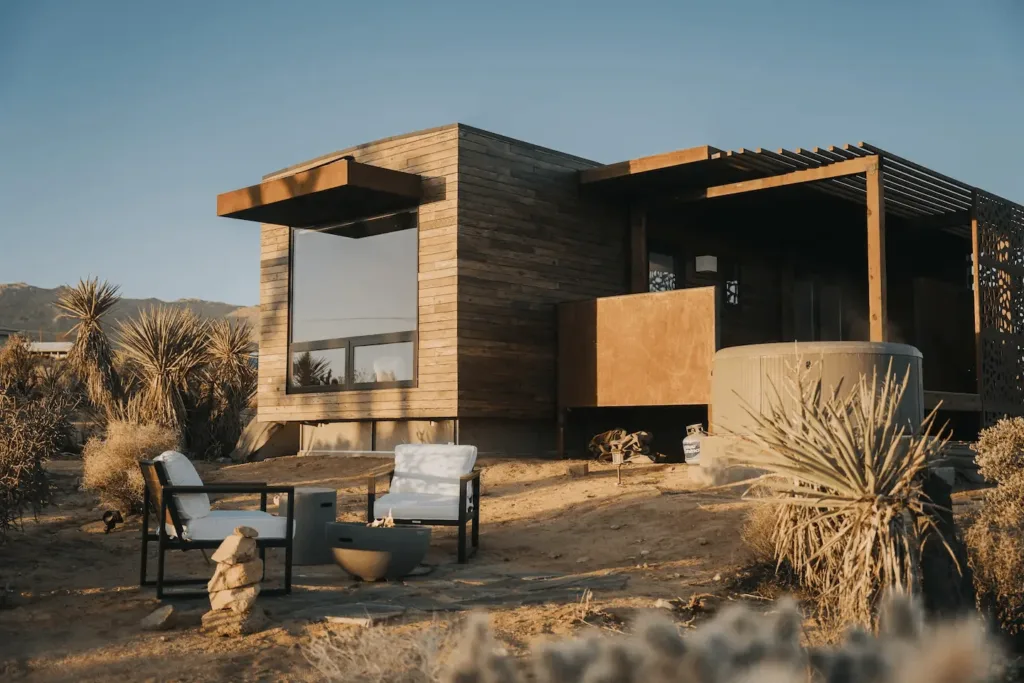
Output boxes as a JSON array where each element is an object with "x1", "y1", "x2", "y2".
[{"x1": 82, "y1": 422, "x2": 178, "y2": 514}]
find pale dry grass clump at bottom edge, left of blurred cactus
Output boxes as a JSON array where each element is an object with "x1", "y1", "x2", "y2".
[{"x1": 303, "y1": 624, "x2": 451, "y2": 683}]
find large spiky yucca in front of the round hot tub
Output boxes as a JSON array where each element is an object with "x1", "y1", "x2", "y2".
[{"x1": 744, "y1": 366, "x2": 952, "y2": 626}]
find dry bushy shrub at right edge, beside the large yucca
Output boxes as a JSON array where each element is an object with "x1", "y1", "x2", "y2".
[{"x1": 965, "y1": 418, "x2": 1024, "y2": 634}]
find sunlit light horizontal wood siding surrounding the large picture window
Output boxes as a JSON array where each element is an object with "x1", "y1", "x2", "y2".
[{"x1": 258, "y1": 125, "x2": 459, "y2": 421}]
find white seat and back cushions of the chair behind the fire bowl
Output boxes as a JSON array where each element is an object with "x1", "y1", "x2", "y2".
[{"x1": 390, "y1": 443, "x2": 476, "y2": 497}]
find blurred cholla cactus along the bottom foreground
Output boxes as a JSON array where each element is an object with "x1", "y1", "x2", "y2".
[{"x1": 442, "y1": 595, "x2": 996, "y2": 683}]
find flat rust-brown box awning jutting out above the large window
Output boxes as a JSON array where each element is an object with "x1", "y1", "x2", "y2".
[{"x1": 217, "y1": 158, "x2": 422, "y2": 227}]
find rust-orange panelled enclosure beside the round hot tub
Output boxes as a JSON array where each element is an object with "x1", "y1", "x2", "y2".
[{"x1": 558, "y1": 287, "x2": 717, "y2": 408}]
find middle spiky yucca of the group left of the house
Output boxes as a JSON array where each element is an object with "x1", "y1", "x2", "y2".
[{"x1": 118, "y1": 306, "x2": 209, "y2": 431}]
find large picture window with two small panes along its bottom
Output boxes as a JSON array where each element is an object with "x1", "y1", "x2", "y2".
[{"x1": 288, "y1": 211, "x2": 419, "y2": 393}]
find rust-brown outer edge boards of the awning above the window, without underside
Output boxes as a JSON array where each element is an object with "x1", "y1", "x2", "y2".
[{"x1": 217, "y1": 159, "x2": 422, "y2": 216}]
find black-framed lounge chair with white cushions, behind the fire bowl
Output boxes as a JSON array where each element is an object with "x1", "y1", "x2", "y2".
[{"x1": 367, "y1": 443, "x2": 480, "y2": 563}]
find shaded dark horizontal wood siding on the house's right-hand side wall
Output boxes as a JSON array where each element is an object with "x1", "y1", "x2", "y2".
[{"x1": 458, "y1": 126, "x2": 628, "y2": 418}]
